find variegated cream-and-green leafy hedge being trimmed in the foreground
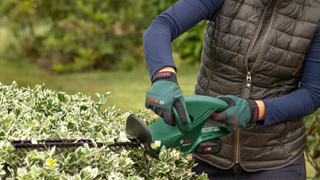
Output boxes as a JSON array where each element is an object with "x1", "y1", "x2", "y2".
[{"x1": 0, "y1": 82, "x2": 207, "y2": 180}]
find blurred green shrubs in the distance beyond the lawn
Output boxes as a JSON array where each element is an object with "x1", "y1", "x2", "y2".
[{"x1": 0, "y1": 0, "x2": 205, "y2": 73}]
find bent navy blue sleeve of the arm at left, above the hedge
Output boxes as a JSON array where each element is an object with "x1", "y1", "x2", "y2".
[{"x1": 143, "y1": 0, "x2": 223, "y2": 77}]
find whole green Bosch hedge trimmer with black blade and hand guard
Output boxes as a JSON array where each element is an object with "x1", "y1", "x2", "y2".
[{"x1": 11, "y1": 95, "x2": 229, "y2": 158}]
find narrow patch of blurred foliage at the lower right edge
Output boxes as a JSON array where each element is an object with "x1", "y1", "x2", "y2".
[{"x1": 305, "y1": 109, "x2": 320, "y2": 178}]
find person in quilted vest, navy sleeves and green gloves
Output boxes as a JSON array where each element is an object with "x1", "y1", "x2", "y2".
[{"x1": 143, "y1": 0, "x2": 320, "y2": 180}]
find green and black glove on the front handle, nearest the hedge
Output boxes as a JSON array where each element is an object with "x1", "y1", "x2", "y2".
[{"x1": 145, "y1": 71, "x2": 190, "y2": 126}]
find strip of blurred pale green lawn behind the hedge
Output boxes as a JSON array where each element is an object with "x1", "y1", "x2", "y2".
[{"x1": 0, "y1": 63, "x2": 197, "y2": 113}]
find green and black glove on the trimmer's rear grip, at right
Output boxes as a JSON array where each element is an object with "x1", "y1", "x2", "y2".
[{"x1": 211, "y1": 95, "x2": 259, "y2": 132}]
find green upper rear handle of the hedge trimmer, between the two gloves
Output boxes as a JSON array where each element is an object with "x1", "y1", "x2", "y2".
[{"x1": 173, "y1": 95, "x2": 228, "y2": 133}]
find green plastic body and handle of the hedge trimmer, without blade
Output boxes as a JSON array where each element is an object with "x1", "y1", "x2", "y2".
[{"x1": 148, "y1": 95, "x2": 229, "y2": 154}]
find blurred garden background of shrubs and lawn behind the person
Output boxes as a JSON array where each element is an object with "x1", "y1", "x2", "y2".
[{"x1": 0, "y1": 0, "x2": 320, "y2": 179}]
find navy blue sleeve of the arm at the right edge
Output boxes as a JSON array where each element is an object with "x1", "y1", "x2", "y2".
[{"x1": 258, "y1": 27, "x2": 320, "y2": 126}]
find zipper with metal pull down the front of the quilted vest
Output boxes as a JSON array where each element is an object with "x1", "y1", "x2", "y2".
[{"x1": 236, "y1": 0, "x2": 280, "y2": 164}]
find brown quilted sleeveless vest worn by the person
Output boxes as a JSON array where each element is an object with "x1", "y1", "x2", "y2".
[{"x1": 194, "y1": 0, "x2": 320, "y2": 172}]
